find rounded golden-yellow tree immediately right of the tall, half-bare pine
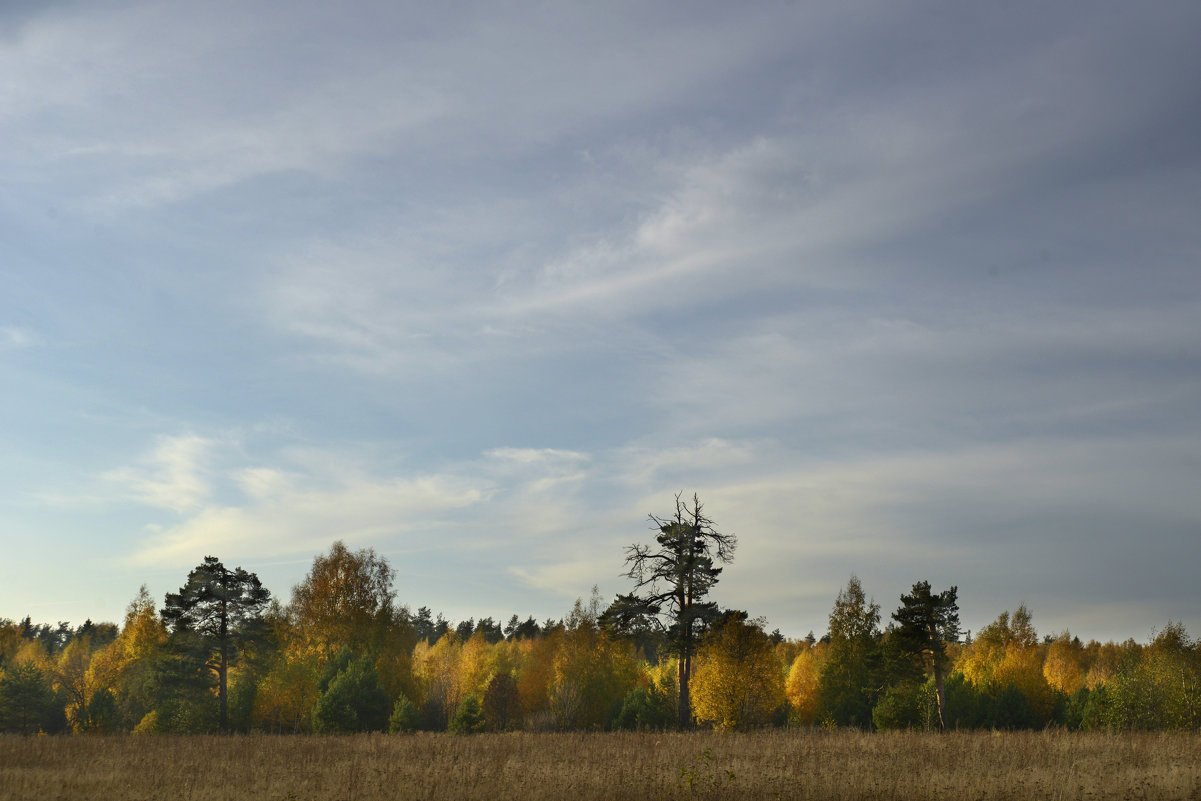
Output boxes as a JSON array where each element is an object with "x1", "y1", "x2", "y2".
[{"x1": 693, "y1": 614, "x2": 784, "y2": 729}]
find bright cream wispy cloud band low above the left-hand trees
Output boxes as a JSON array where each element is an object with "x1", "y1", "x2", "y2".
[{"x1": 124, "y1": 435, "x2": 610, "y2": 567}]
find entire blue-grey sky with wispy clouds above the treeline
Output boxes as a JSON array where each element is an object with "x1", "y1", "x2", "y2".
[{"x1": 0, "y1": 0, "x2": 1201, "y2": 641}]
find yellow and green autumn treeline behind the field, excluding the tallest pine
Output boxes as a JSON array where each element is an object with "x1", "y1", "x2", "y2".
[{"x1": 0, "y1": 543, "x2": 1201, "y2": 734}]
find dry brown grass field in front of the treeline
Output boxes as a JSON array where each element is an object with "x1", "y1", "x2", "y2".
[{"x1": 0, "y1": 731, "x2": 1201, "y2": 801}]
